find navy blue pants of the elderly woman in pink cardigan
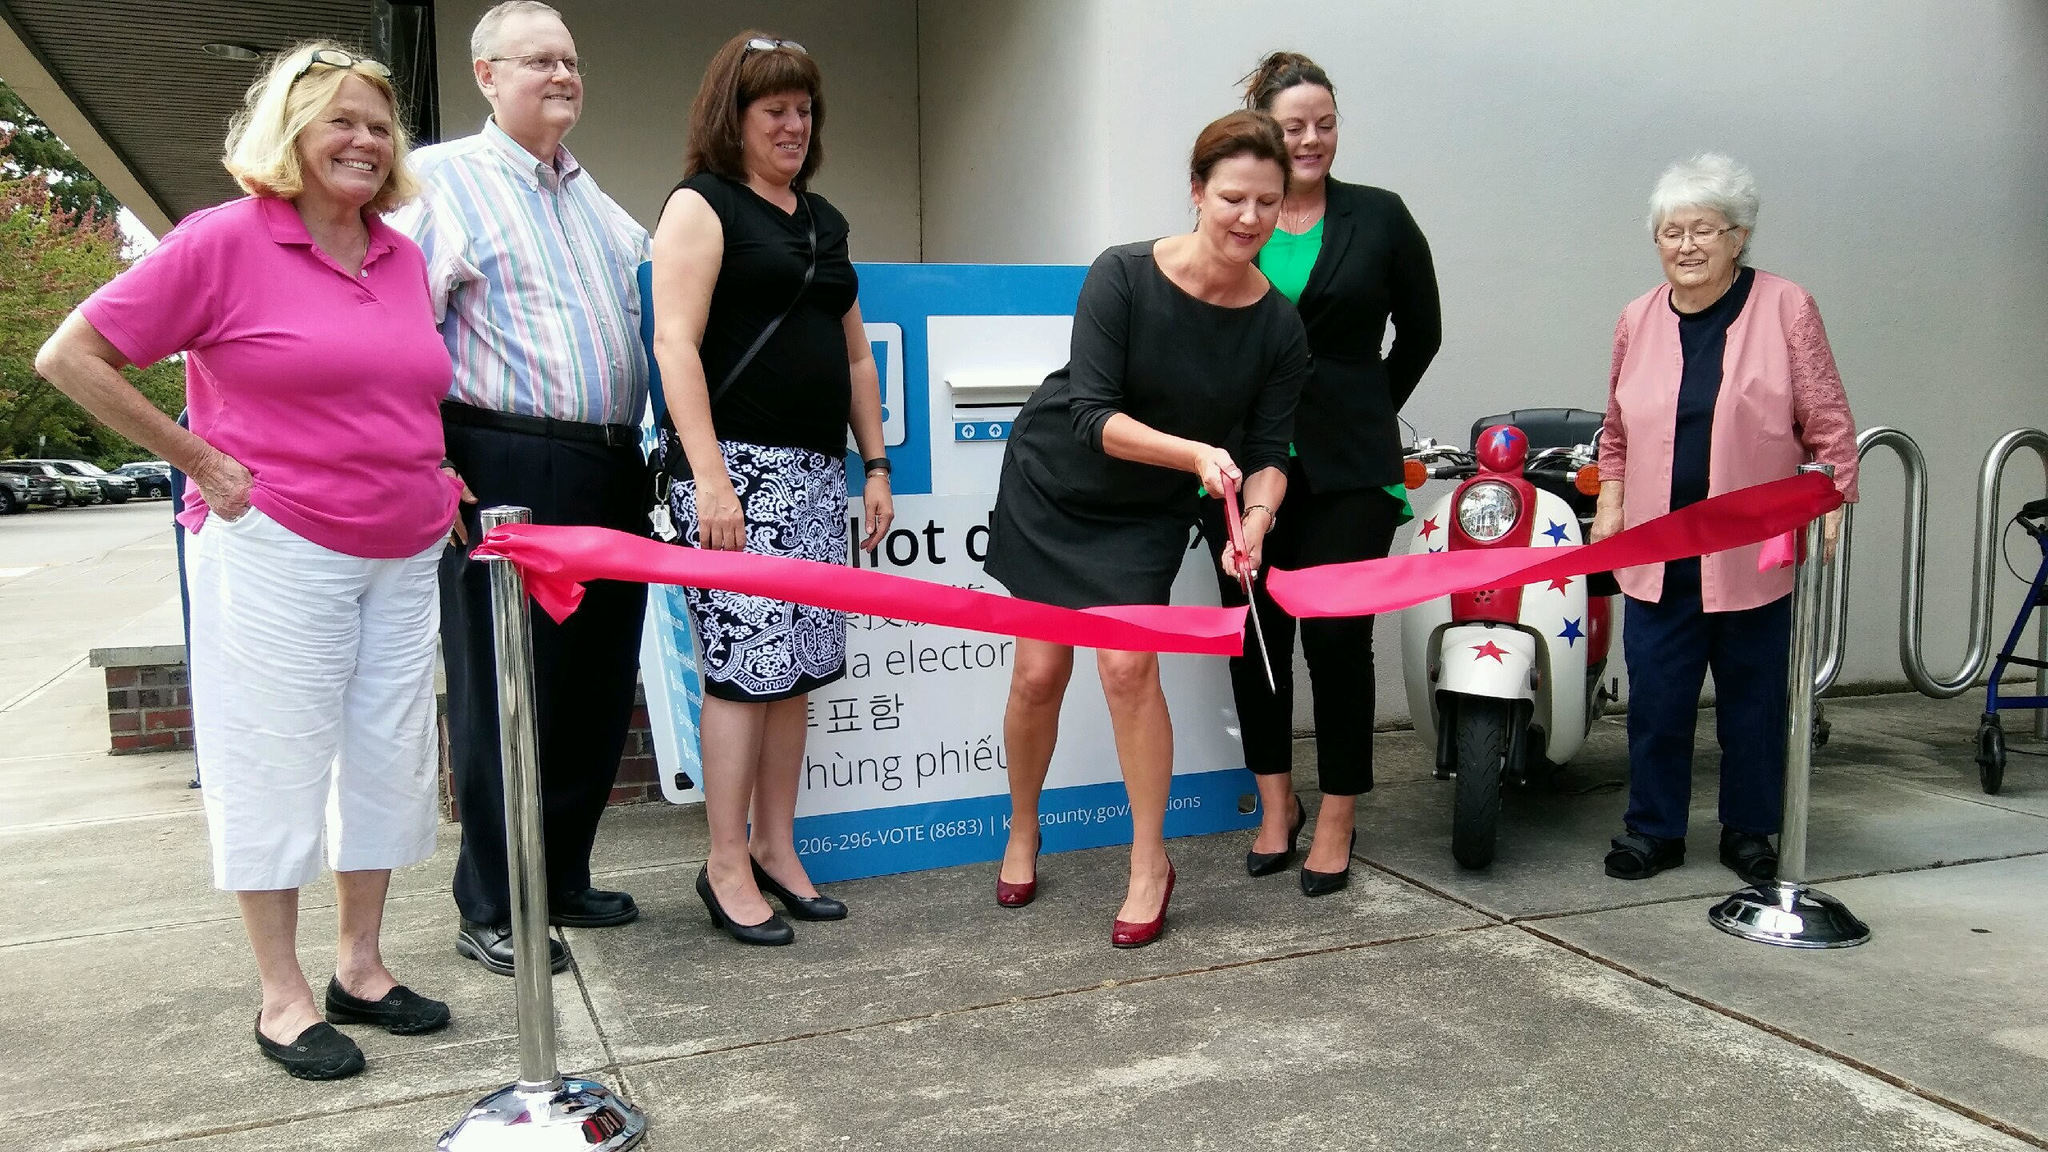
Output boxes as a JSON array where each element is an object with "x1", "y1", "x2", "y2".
[{"x1": 1622, "y1": 590, "x2": 1792, "y2": 840}]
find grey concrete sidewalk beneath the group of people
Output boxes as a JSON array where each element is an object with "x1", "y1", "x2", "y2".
[{"x1": 0, "y1": 670, "x2": 2048, "y2": 1152}]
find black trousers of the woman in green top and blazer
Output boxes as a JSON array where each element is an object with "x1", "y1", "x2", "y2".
[{"x1": 1202, "y1": 467, "x2": 1401, "y2": 795}]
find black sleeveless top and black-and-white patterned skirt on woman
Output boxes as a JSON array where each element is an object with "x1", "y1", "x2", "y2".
[{"x1": 670, "y1": 172, "x2": 858, "y2": 701}]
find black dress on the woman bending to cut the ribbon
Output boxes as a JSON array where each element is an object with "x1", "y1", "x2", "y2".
[{"x1": 985, "y1": 240, "x2": 1309, "y2": 609}]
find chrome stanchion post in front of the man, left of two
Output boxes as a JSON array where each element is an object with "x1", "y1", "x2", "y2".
[{"x1": 438, "y1": 506, "x2": 647, "y2": 1152}]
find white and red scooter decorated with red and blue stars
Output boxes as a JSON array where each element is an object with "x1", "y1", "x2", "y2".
[{"x1": 1401, "y1": 408, "x2": 1620, "y2": 869}]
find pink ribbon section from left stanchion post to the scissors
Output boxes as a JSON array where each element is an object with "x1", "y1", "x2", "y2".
[{"x1": 471, "y1": 525, "x2": 1245, "y2": 656}]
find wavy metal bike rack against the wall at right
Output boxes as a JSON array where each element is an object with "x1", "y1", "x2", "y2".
[{"x1": 1812, "y1": 426, "x2": 2048, "y2": 738}]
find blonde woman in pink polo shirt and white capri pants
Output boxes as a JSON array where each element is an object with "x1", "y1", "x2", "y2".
[{"x1": 35, "y1": 41, "x2": 461, "y2": 1080}]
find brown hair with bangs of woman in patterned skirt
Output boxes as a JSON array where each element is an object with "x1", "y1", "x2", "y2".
[{"x1": 682, "y1": 29, "x2": 825, "y2": 189}]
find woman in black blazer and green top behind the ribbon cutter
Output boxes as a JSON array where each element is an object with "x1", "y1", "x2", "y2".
[{"x1": 1204, "y1": 51, "x2": 1444, "y2": 896}]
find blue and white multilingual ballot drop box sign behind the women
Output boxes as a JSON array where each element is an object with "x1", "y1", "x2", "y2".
[{"x1": 643, "y1": 264, "x2": 1257, "y2": 881}]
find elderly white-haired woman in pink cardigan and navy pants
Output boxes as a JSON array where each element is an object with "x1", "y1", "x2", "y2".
[{"x1": 1591, "y1": 154, "x2": 1855, "y2": 883}]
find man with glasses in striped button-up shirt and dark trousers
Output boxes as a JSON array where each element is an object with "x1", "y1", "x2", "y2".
[{"x1": 393, "y1": 0, "x2": 651, "y2": 976}]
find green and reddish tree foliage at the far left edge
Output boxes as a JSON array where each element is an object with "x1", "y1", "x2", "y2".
[{"x1": 0, "y1": 86, "x2": 184, "y2": 467}]
